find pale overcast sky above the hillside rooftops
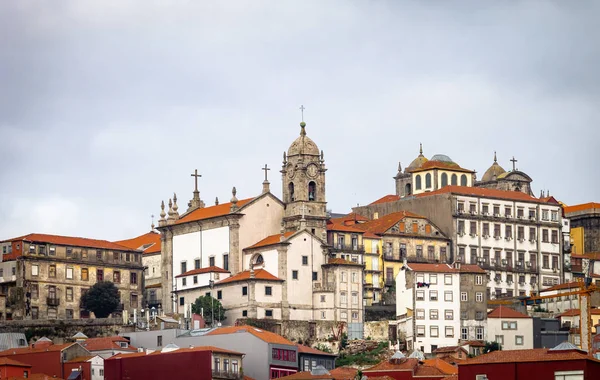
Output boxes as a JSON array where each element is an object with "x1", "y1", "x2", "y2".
[{"x1": 0, "y1": 0, "x2": 600, "y2": 240}]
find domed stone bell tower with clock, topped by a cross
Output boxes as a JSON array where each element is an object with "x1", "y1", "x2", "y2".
[{"x1": 281, "y1": 122, "x2": 327, "y2": 239}]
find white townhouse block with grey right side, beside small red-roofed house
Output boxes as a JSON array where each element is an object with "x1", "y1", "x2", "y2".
[{"x1": 396, "y1": 263, "x2": 486, "y2": 354}]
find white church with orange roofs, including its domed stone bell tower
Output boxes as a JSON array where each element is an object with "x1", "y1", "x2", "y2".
[{"x1": 158, "y1": 122, "x2": 363, "y2": 324}]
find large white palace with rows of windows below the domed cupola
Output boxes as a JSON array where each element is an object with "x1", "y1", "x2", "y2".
[{"x1": 354, "y1": 185, "x2": 570, "y2": 299}]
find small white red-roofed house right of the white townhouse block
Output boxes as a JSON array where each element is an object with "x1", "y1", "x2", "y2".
[{"x1": 487, "y1": 306, "x2": 533, "y2": 351}]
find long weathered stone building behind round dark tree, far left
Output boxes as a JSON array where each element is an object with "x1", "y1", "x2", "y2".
[{"x1": 0, "y1": 234, "x2": 143, "y2": 319}]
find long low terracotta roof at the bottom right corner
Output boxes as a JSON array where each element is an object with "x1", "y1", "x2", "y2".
[{"x1": 458, "y1": 348, "x2": 593, "y2": 368}]
